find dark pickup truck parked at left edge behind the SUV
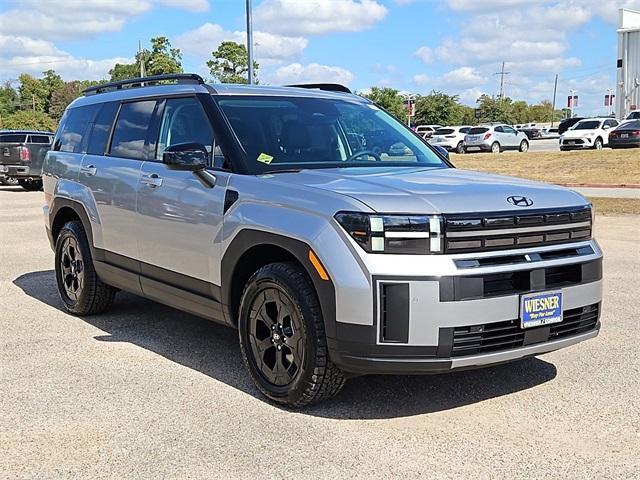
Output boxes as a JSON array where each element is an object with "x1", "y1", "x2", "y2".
[{"x1": 0, "y1": 130, "x2": 53, "y2": 190}]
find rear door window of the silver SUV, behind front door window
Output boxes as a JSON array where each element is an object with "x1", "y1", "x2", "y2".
[{"x1": 110, "y1": 100, "x2": 156, "y2": 160}]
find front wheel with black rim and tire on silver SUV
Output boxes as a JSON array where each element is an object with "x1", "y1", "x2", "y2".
[{"x1": 238, "y1": 262, "x2": 345, "y2": 407}]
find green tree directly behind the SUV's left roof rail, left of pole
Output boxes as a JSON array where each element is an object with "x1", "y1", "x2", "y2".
[{"x1": 109, "y1": 37, "x2": 183, "y2": 82}]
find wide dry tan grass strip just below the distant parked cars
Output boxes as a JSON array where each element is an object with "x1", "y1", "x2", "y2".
[{"x1": 451, "y1": 148, "x2": 640, "y2": 184}]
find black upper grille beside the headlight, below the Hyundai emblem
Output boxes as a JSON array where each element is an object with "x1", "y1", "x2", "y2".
[{"x1": 445, "y1": 206, "x2": 591, "y2": 253}]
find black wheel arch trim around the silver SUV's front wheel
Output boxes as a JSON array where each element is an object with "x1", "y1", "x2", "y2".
[{"x1": 221, "y1": 228, "x2": 336, "y2": 337}]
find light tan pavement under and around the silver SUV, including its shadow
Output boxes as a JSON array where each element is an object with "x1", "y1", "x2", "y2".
[{"x1": 0, "y1": 188, "x2": 640, "y2": 479}]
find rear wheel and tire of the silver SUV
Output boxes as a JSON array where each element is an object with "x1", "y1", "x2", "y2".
[{"x1": 55, "y1": 221, "x2": 117, "y2": 316}]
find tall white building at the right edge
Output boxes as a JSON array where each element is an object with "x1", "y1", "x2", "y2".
[{"x1": 616, "y1": 8, "x2": 640, "y2": 118}]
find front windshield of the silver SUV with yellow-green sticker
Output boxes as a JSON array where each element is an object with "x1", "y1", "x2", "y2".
[{"x1": 218, "y1": 96, "x2": 447, "y2": 174}]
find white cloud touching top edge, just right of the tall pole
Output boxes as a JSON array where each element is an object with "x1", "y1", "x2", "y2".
[{"x1": 254, "y1": 0, "x2": 387, "y2": 35}]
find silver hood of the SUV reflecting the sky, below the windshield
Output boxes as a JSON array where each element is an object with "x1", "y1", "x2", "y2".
[{"x1": 264, "y1": 167, "x2": 588, "y2": 213}]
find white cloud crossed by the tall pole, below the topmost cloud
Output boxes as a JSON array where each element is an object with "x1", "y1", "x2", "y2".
[{"x1": 174, "y1": 23, "x2": 309, "y2": 63}]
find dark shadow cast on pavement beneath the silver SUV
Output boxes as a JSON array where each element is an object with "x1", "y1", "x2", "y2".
[{"x1": 13, "y1": 270, "x2": 557, "y2": 419}]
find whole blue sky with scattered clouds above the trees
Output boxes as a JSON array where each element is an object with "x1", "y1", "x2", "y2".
[{"x1": 0, "y1": 0, "x2": 640, "y2": 114}]
